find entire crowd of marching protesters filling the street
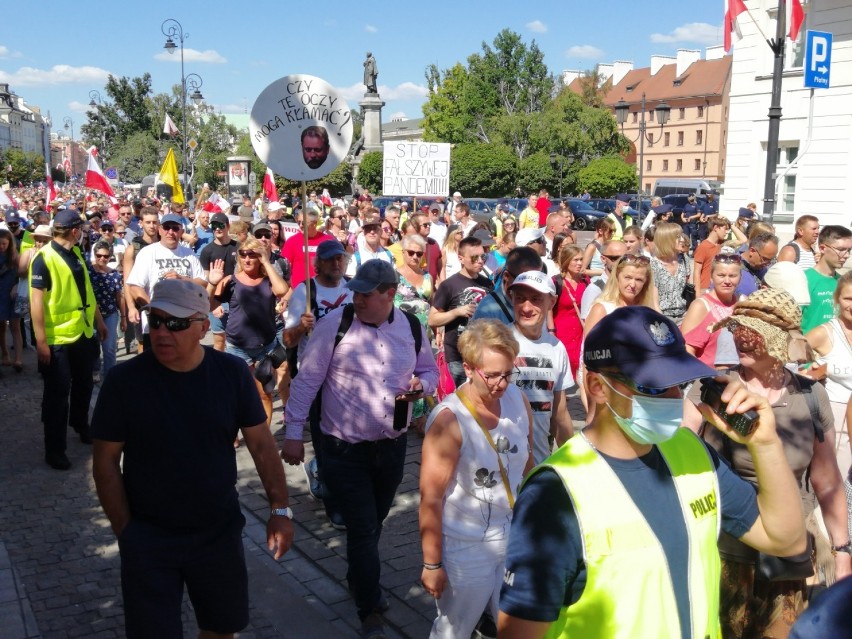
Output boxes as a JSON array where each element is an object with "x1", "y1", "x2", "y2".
[{"x1": 0, "y1": 181, "x2": 852, "y2": 639}]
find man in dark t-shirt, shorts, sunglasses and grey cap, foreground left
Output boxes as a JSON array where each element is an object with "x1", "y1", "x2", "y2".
[{"x1": 92, "y1": 279, "x2": 293, "y2": 639}]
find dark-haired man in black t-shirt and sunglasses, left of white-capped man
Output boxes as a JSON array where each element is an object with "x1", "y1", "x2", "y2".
[{"x1": 429, "y1": 237, "x2": 494, "y2": 387}]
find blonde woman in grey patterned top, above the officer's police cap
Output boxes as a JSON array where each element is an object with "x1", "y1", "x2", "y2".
[{"x1": 651, "y1": 222, "x2": 691, "y2": 324}]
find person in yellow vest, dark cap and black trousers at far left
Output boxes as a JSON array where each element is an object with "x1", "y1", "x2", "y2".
[{"x1": 30, "y1": 209, "x2": 107, "y2": 470}]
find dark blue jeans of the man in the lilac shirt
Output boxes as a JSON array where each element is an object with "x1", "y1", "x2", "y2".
[{"x1": 322, "y1": 433, "x2": 408, "y2": 621}]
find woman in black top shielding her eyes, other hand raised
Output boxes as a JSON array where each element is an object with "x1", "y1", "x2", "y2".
[{"x1": 207, "y1": 237, "x2": 290, "y2": 423}]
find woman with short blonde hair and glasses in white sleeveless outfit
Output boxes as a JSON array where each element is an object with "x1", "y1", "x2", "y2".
[{"x1": 420, "y1": 320, "x2": 532, "y2": 639}]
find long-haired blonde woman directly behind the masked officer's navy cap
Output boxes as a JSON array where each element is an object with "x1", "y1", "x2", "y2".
[{"x1": 584, "y1": 255, "x2": 658, "y2": 335}]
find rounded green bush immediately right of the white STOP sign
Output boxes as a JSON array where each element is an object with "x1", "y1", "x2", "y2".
[{"x1": 450, "y1": 143, "x2": 518, "y2": 197}]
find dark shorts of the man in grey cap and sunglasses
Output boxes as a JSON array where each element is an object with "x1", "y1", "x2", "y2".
[{"x1": 118, "y1": 514, "x2": 249, "y2": 639}]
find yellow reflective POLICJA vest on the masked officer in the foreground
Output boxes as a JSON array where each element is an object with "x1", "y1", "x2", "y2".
[{"x1": 533, "y1": 428, "x2": 721, "y2": 639}]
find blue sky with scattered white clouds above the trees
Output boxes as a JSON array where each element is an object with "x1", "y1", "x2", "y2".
[{"x1": 0, "y1": 0, "x2": 723, "y2": 136}]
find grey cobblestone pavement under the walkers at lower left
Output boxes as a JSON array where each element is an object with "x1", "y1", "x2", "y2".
[{"x1": 0, "y1": 340, "x2": 582, "y2": 639}]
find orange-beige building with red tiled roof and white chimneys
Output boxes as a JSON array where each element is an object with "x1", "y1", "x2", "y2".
[{"x1": 598, "y1": 47, "x2": 731, "y2": 194}]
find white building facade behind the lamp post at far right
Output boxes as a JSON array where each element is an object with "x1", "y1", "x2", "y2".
[{"x1": 722, "y1": 0, "x2": 852, "y2": 226}]
